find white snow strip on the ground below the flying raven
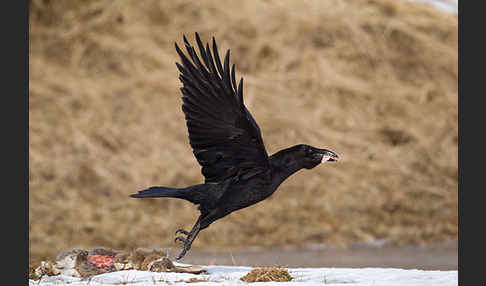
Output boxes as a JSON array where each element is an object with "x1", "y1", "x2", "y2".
[{"x1": 29, "y1": 266, "x2": 458, "y2": 286}]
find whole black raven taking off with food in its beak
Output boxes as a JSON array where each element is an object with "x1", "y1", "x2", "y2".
[{"x1": 130, "y1": 33, "x2": 338, "y2": 260}]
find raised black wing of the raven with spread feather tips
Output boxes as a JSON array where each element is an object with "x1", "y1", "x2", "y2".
[{"x1": 175, "y1": 33, "x2": 268, "y2": 183}]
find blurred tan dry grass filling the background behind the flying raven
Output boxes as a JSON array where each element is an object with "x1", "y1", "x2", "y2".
[{"x1": 29, "y1": 0, "x2": 458, "y2": 260}]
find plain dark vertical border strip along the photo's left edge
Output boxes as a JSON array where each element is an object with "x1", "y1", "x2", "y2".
[{"x1": 8, "y1": 0, "x2": 30, "y2": 285}]
